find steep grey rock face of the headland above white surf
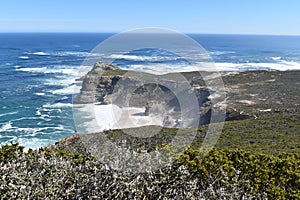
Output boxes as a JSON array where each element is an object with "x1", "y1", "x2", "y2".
[{"x1": 73, "y1": 62, "x2": 225, "y2": 127}]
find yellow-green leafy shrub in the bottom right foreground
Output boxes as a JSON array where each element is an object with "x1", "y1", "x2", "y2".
[{"x1": 177, "y1": 148, "x2": 300, "y2": 199}]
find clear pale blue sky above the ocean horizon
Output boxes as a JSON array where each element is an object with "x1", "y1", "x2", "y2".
[{"x1": 0, "y1": 0, "x2": 300, "y2": 35}]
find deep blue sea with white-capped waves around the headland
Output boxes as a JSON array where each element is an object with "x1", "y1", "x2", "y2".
[{"x1": 0, "y1": 33, "x2": 300, "y2": 148}]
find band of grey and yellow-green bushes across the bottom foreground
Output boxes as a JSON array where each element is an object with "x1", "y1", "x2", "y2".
[{"x1": 0, "y1": 144, "x2": 300, "y2": 199}]
